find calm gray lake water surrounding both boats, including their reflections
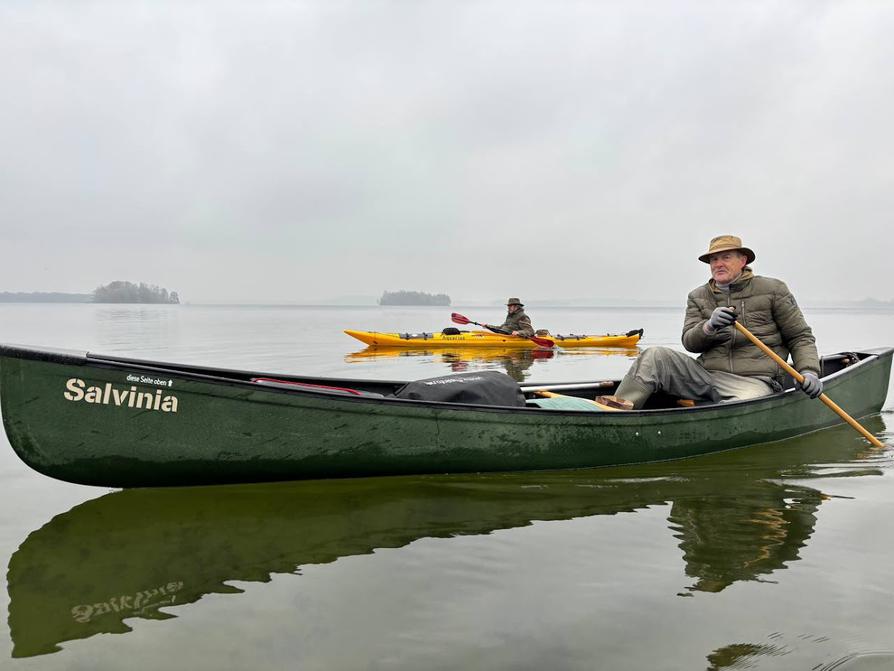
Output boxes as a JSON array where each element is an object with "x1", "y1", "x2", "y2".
[{"x1": 0, "y1": 304, "x2": 894, "y2": 671}]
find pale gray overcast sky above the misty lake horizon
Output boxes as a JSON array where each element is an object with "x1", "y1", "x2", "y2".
[{"x1": 0, "y1": 0, "x2": 894, "y2": 304}]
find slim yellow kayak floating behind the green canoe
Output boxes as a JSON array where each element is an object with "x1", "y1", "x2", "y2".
[{"x1": 345, "y1": 329, "x2": 643, "y2": 349}]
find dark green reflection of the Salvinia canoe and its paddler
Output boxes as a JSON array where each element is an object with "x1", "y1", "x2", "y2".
[{"x1": 7, "y1": 417, "x2": 884, "y2": 657}]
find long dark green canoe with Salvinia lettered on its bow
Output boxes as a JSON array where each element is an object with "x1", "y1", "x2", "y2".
[{"x1": 0, "y1": 345, "x2": 894, "y2": 487}]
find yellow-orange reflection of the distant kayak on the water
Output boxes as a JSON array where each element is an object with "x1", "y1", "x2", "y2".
[{"x1": 345, "y1": 347, "x2": 640, "y2": 382}]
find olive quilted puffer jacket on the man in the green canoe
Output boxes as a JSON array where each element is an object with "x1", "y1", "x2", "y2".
[{"x1": 683, "y1": 268, "x2": 820, "y2": 384}]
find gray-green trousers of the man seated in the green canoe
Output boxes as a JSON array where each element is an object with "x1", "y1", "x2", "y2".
[{"x1": 615, "y1": 347, "x2": 776, "y2": 408}]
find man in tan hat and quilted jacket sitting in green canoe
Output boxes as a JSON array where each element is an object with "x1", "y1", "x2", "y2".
[{"x1": 597, "y1": 235, "x2": 823, "y2": 410}]
